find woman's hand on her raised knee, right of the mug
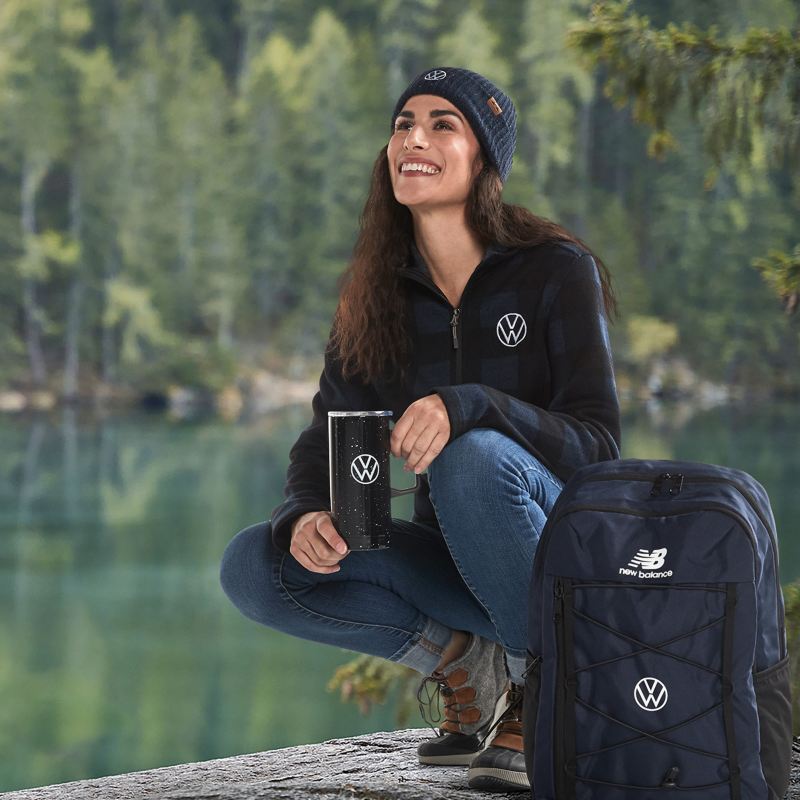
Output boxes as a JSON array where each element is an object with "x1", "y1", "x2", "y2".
[{"x1": 391, "y1": 394, "x2": 450, "y2": 475}]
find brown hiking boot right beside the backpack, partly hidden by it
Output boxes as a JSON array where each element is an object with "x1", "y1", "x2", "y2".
[{"x1": 467, "y1": 683, "x2": 531, "y2": 792}]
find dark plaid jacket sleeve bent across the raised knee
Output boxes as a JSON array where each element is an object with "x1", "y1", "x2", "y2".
[{"x1": 435, "y1": 253, "x2": 620, "y2": 481}]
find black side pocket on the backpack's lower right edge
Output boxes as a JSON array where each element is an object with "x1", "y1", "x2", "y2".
[{"x1": 753, "y1": 655, "x2": 792, "y2": 800}]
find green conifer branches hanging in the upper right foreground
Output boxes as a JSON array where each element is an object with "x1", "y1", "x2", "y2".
[{"x1": 568, "y1": 0, "x2": 800, "y2": 311}]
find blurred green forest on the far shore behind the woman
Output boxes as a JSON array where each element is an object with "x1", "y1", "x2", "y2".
[{"x1": 0, "y1": 0, "x2": 800, "y2": 401}]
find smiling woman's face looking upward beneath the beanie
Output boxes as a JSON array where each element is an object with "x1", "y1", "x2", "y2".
[{"x1": 387, "y1": 94, "x2": 482, "y2": 210}]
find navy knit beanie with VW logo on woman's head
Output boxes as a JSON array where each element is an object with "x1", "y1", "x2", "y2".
[{"x1": 392, "y1": 67, "x2": 517, "y2": 183}]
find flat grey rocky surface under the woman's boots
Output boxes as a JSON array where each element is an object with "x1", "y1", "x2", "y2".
[{"x1": 2, "y1": 729, "x2": 800, "y2": 800}]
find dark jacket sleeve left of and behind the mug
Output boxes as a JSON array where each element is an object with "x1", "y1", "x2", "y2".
[{"x1": 271, "y1": 340, "x2": 380, "y2": 553}]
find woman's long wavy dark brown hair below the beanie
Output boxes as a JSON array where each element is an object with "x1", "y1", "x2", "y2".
[{"x1": 329, "y1": 145, "x2": 617, "y2": 390}]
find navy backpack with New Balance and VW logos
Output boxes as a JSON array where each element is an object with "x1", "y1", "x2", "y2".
[{"x1": 522, "y1": 459, "x2": 792, "y2": 800}]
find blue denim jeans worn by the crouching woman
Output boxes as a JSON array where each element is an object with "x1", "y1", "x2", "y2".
[{"x1": 220, "y1": 428, "x2": 563, "y2": 683}]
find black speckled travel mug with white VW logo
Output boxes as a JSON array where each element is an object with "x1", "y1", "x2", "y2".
[{"x1": 328, "y1": 411, "x2": 419, "y2": 550}]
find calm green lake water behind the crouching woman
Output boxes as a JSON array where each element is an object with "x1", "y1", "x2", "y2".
[{"x1": 0, "y1": 404, "x2": 800, "y2": 791}]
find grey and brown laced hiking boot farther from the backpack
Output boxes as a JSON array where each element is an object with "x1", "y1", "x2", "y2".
[{"x1": 417, "y1": 634, "x2": 508, "y2": 766}]
